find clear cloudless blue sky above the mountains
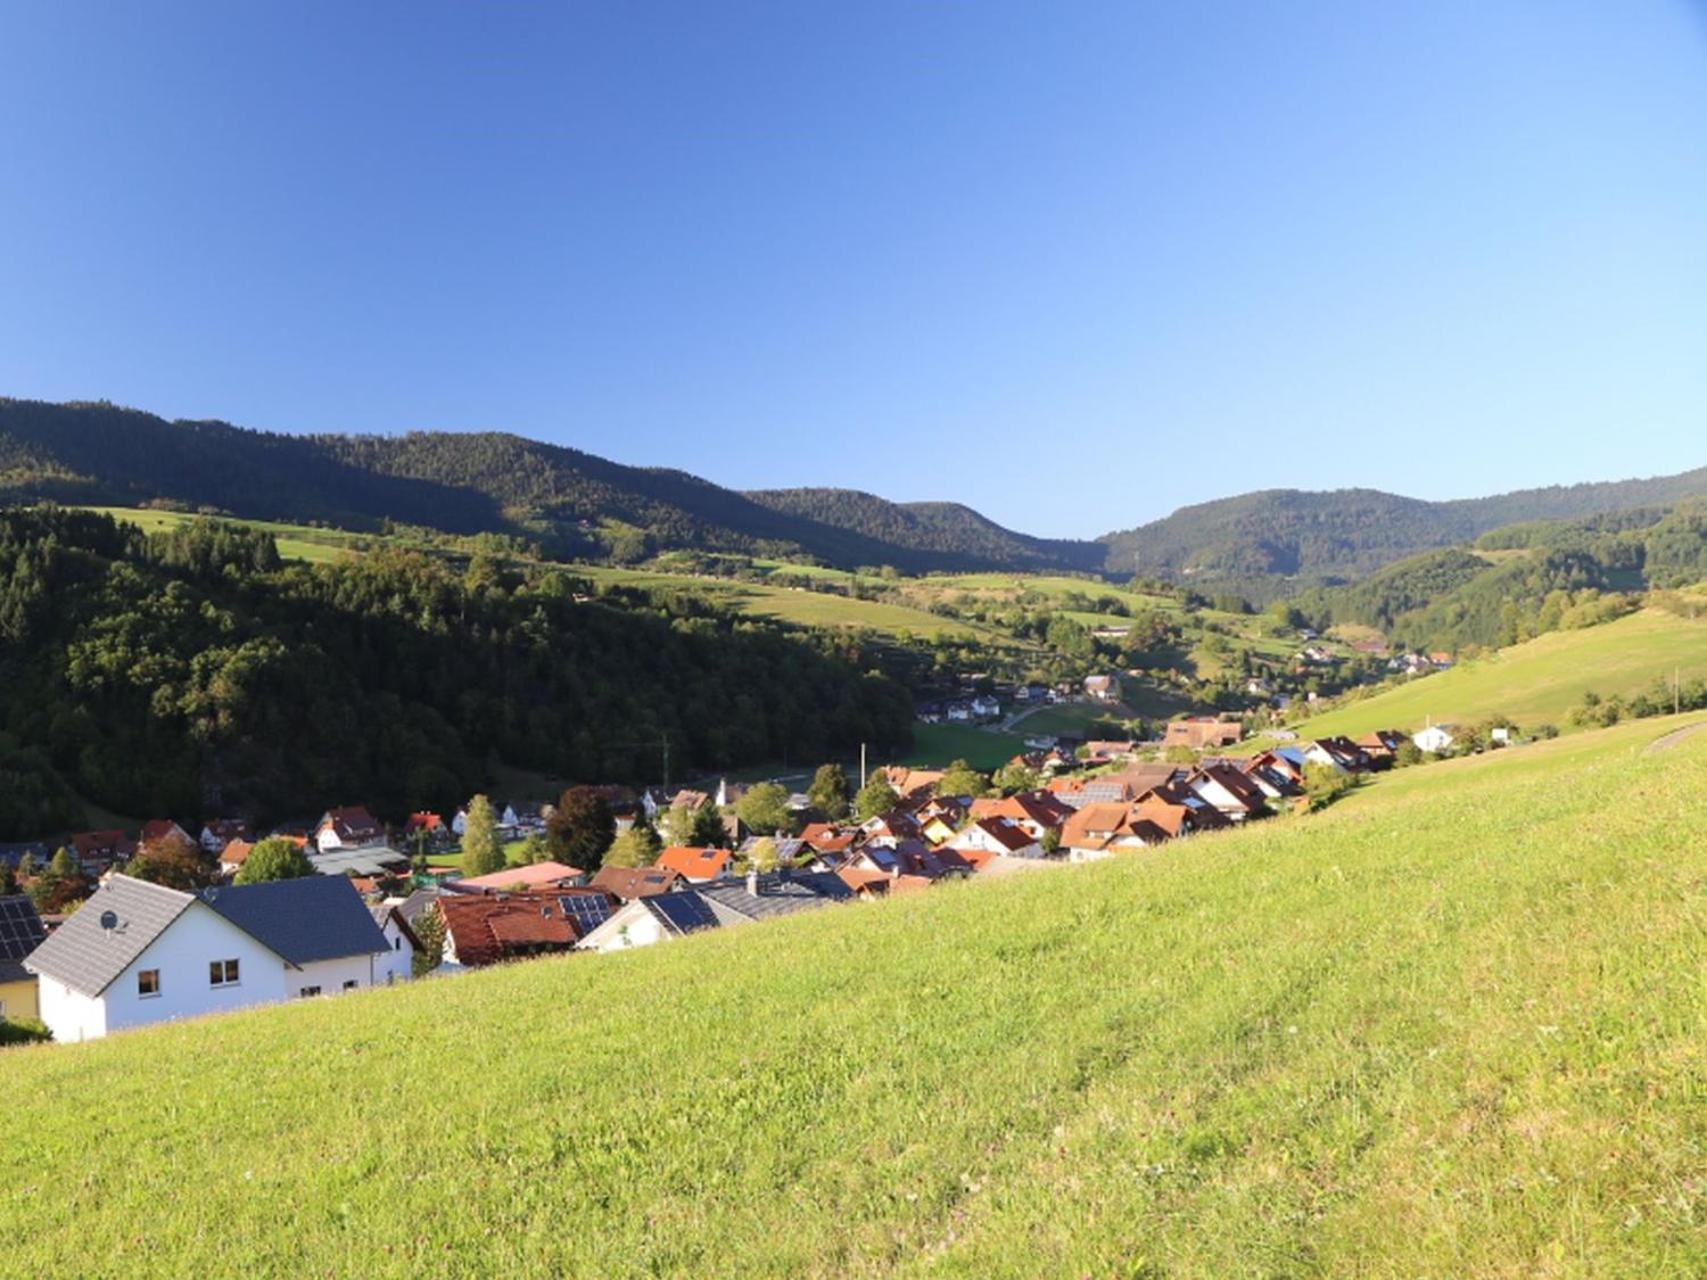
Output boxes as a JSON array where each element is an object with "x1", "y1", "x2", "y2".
[{"x1": 0, "y1": 0, "x2": 1707, "y2": 534}]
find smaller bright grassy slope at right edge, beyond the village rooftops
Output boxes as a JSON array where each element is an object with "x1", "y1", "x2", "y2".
[{"x1": 1299, "y1": 609, "x2": 1707, "y2": 737}]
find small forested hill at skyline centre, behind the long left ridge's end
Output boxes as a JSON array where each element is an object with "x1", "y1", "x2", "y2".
[{"x1": 746, "y1": 488, "x2": 1103, "y2": 572}]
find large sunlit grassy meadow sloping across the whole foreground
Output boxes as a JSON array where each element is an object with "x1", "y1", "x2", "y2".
[{"x1": 0, "y1": 722, "x2": 1707, "y2": 1280}]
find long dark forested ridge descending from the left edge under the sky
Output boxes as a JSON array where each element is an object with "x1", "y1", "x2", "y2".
[{"x1": 0, "y1": 399, "x2": 1094, "y2": 572}]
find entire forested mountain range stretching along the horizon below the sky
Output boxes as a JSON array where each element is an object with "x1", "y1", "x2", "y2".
[{"x1": 0, "y1": 399, "x2": 1707, "y2": 583}]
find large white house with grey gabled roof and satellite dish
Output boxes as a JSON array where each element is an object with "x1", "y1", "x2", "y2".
[{"x1": 26, "y1": 876, "x2": 399, "y2": 1041}]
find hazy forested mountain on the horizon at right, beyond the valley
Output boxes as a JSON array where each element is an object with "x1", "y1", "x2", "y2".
[{"x1": 1103, "y1": 468, "x2": 1707, "y2": 582}]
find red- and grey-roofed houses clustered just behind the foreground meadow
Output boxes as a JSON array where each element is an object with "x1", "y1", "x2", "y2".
[{"x1": 0, "y1": 717, "x2": 1449, "y2": 1041}]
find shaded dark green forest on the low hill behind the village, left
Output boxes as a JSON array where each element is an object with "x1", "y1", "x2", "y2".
[{"x1": 0, "y1": 507, "x2": 912, "y2": 838}]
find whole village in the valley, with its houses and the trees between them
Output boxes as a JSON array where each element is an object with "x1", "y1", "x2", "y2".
[{"x1": 0, "y1": 650, "x2": 1481, "y2": 1043}]
